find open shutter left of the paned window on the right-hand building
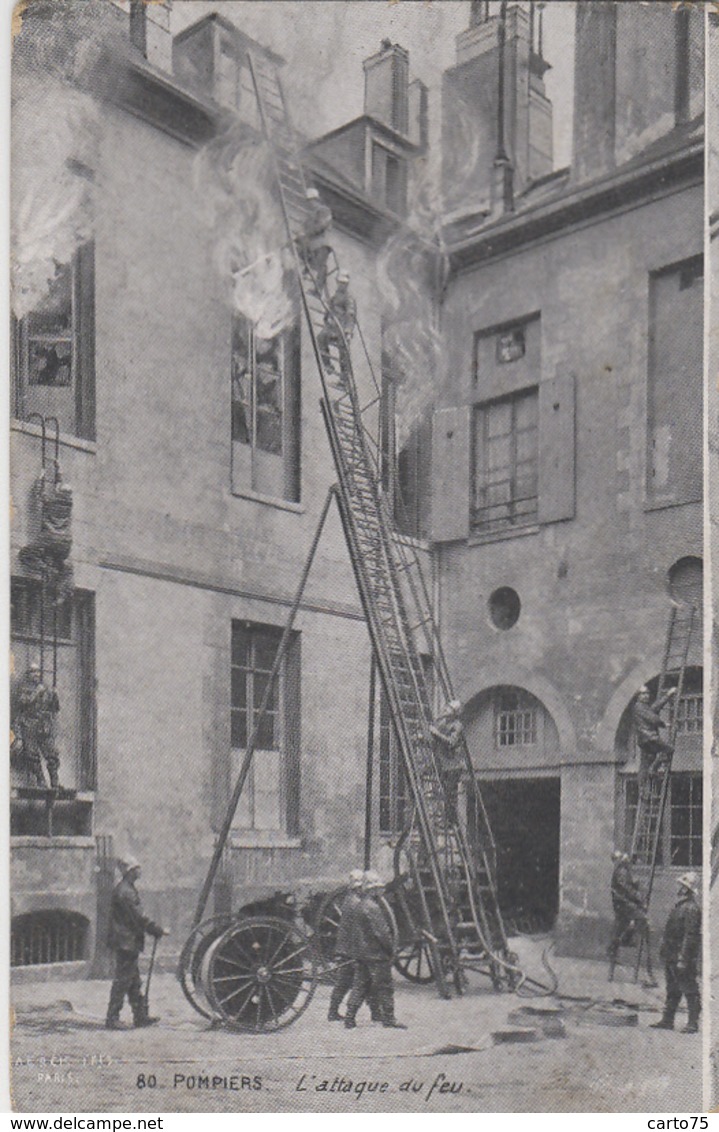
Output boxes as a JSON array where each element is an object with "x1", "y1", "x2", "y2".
[{"x1": 430, "y1": 405, "x2": 471, "y2": 542}]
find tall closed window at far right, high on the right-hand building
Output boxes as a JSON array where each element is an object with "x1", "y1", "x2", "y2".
[{"x1": 647, "y1": 256, "x2": 703, "y2": 505}]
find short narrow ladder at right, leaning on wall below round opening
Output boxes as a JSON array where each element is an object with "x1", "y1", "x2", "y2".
[{"x1": 631, "y1": 602, "x2": 696, "y2": 976}]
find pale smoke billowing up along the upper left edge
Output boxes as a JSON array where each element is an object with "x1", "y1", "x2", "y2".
[{"x1": 10, "y1": 0, "x2": 120, "y2": 318}]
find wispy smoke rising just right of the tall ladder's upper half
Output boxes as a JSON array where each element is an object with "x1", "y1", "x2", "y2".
[{"x1": 376, "y1": 163, "x2": 446, "y2": 448}]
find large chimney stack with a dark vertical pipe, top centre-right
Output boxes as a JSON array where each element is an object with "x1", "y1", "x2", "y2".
[{"x1": 442, "y1": 3, "x2": 554, "y2": 218}]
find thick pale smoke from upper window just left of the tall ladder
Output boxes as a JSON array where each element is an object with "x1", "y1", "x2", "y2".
[{"x1": 195, "y1": 122, "x2": 296, "y2": 338}]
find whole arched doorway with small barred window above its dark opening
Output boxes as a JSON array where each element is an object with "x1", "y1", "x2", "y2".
[{"x1": 467, "y1": 685, "x2": 560, "y2": 932}]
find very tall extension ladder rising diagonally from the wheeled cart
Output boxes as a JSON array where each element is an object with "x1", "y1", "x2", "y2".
[{"x1": 250, "y1": 57, "x2": 519, "y2": 995}]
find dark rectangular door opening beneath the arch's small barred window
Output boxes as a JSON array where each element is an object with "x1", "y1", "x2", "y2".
[{"x1": 470, "y1": 778, "x2": 560, "y2": 932}]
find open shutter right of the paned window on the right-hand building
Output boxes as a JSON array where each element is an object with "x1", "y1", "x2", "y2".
[{"x1": 539, "y1": 374, "x2": 575, "y2": 523}]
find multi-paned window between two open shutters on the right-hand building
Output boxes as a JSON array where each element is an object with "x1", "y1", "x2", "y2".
[{"x1": 471, "y1": 389, "x2": 538, "y2": 532}]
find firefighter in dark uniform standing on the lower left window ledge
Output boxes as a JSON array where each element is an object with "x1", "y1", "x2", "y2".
[{"x1": 12, "y1": 667, "x2": 60, "y2": 789}]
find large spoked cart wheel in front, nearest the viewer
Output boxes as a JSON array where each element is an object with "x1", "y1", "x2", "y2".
[{"x1": 202, "y1": 916, "x2": 317, "y2": 1034}]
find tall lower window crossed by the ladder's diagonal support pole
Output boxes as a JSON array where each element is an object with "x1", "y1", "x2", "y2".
[{"x1": 230, "y1": 621, "x2": 299, "y2": 833}]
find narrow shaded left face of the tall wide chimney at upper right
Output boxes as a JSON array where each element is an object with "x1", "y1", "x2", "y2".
[{"x1": 572, "y1": 0, "x2": 620, "y2": 181}]
